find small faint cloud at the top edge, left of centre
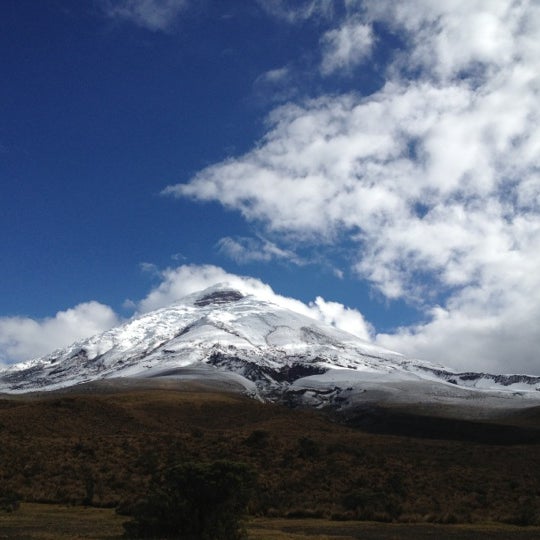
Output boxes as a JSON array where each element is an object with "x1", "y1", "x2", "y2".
[{"x1": 102, "y1": 0, "x2": 188, "y2": 31}]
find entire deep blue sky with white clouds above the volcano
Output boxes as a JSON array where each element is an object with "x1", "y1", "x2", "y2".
[{"x1": 0, "y1": 0, "x2": 540, "y2": 374}]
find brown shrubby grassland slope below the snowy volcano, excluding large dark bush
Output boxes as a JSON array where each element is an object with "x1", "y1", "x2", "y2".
[{"x1": 0, "y1": 385, "x2": 540, "y2": 540}]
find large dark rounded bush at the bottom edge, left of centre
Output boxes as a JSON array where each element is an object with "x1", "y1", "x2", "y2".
[{"x1": 124, "y1": 461, "x2": 255, "y2": 540}]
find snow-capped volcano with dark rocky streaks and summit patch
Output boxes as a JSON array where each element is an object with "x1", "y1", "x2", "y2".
[{"x1": 0, "y1": 286, "x2": 540, "y2": 406}]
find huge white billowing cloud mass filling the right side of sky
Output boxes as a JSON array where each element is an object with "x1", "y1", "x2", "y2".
[{"x1": 166, "y1": 0, "x2": 540, "y2": 371}]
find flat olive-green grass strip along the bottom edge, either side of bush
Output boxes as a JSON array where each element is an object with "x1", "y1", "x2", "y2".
[{"x1": 0, "y1": 503, "x2": 540, "y2": 540}]
